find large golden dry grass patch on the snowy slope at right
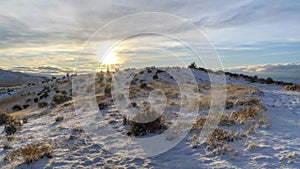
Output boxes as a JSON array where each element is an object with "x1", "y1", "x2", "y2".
[{"x1": 191, "y1": 85, "x2": 267, "y2": 154}]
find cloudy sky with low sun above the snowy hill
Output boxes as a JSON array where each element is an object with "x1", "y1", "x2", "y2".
[{"x1": 0, "y1": 0, "x2": 300, "y2": 80}]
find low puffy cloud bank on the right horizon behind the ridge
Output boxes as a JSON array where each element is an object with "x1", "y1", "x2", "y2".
[{"x1": 226, "y1": 62, "x2": 300, "y2": 84}]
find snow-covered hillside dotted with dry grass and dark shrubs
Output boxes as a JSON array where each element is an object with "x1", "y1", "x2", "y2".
[{"x1": 0, "y1": 67, "x2": 300, "y2": 169}]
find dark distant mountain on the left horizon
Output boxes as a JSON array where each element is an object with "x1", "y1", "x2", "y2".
[{"x1": 0, "y1": 69, "x2": 48, "y2": 87}]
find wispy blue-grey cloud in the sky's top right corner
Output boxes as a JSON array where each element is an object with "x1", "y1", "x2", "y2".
[{"x1": 196, "y1": 0, "x2": 300, "y2": 29}]
